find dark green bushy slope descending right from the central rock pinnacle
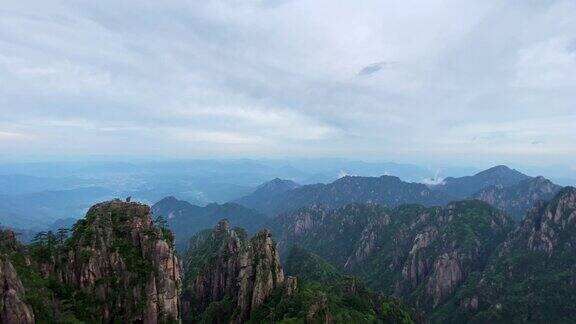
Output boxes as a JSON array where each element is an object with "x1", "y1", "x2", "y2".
[{"x1": 249, "y1": 247, "x2": 416, "y2": 324}]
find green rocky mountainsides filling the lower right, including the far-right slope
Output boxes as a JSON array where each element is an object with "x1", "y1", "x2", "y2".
[{"x1": 271, "y1": 187, "x2": 576, "y2": 323}]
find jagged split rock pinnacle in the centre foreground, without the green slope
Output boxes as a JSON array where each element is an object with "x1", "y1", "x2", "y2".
[{"x1": 183, "y1": 220, "x2": 284, "y2": 323}]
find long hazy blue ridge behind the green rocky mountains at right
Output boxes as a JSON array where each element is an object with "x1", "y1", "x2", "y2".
[{"x1": 236, "y1": 166, "x2": 561, "y2": 220}]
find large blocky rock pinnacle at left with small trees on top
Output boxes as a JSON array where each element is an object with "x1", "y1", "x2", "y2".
[{"x1": 42, "y1": 200, "x2": 181, "y2": 323}]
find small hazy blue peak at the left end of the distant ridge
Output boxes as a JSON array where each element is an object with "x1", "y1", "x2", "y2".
[{"x1": 235, "y1": 178, "x2": 300, "y2": 210}]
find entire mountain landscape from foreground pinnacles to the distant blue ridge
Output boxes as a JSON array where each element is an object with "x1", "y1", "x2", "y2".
[{"x1": 0, "y1": 166, "x2": 576, "y2": 323}]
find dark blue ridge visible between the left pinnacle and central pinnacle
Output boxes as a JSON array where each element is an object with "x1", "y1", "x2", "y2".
[{"x1": 152, "y1": 197, "x2": 268, "y2": 250}]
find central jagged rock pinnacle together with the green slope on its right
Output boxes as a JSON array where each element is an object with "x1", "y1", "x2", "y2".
[{"x1": 183, "y1": 221, "x2": 420, "y2": 323}]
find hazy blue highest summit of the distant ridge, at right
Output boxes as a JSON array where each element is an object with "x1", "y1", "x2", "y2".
[{"x1": 431, "y1": 165, "x2": 530, "y2": 200}]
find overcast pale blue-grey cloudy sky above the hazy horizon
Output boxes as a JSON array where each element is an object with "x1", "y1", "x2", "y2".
[{"x1": 0, "y1": 0, "x2": 576, "y2": 170}]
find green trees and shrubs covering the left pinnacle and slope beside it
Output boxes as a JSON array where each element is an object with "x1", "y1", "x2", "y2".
[{"x1": 0, "y1": 202, "x2": 178, "y2": 323}]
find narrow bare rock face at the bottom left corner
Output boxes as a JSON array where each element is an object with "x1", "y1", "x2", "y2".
[{"x1": 0, "y1": 230, "x2": 34, "y2": 324}]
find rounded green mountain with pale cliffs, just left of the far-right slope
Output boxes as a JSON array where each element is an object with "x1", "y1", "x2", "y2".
[{"x1": 394, "y1": 201, "x2": 512, "y2": 311}]
